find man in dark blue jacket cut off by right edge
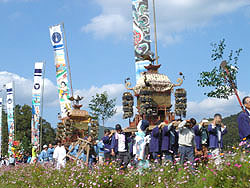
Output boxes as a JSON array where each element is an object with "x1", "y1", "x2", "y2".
[{"x1": 237, "y1": 96, "x2": 250, "y2": 142}]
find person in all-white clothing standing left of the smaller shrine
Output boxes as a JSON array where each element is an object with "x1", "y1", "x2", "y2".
[{"x1": 53, "y1": 141, "x2": 66, "y2": 169}]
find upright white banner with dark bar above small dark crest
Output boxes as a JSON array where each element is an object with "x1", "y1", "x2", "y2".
[{"x1": 31, "y1": 62, "x2": 44, "y2": 146}]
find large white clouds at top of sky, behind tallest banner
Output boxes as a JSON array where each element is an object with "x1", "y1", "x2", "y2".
[{"x1": 82, "y1": 0, "x2": 250, "y2": 44}]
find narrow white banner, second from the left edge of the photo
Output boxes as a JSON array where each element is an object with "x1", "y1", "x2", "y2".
[{"x1": 6, "y1": 82, "x2": 15, "y2": 155}]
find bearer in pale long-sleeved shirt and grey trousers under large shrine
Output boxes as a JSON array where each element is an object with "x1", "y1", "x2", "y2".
[{"x1": 178, "y1": 118, "x2": 196, "y2": 164}]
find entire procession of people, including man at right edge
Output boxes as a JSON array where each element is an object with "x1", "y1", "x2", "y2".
[{"x1": 0, "y1": 97, "x2": 250, "y2": 170}]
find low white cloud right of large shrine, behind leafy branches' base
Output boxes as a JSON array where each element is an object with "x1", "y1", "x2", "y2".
[{"x1": 187, "y1": 92, "x2": 247, "y2": 120}]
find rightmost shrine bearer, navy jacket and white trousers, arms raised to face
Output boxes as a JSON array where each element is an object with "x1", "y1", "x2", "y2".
[{"x1": 208, "y1": 114, "x2": 227, "y2": 165}]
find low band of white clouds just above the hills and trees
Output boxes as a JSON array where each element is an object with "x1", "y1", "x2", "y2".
[{"x1": 0, "y1": 71, "x2": 247, "y2": 127}]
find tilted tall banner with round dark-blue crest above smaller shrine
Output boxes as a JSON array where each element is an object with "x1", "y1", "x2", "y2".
[{"x1": 50, "y1": 25, "x2": 71, "y2": 118}]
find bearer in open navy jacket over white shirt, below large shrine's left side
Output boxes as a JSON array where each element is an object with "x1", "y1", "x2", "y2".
[{"x1": 111, "y1": 124, "x2": 131, "y2": 170}]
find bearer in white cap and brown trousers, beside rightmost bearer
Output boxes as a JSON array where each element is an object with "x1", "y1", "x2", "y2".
[{"x1": 193, "y1": 119, "x2": 209, "y2": 161}]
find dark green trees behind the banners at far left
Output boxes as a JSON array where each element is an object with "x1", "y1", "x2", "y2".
[{"x1": 2, "y1": 105, "x2": 56, "y2": 155}]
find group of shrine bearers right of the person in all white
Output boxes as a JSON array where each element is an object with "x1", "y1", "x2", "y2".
[{"x1": 61, "y1": 114, "x2": 227, "y2": 169}]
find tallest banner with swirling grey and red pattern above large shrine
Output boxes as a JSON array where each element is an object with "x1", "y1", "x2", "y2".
[{"x1": 132, "y1": 0, "x2": 151, "y2": 80}]
